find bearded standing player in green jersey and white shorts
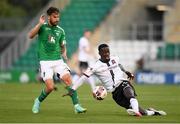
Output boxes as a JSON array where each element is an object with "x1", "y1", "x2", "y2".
[{"x1": 29, "y1": 7, "x2": 86, "y2": 113}]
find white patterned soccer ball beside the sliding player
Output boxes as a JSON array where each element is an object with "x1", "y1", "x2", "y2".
[{"x1": 93, "y1": 86, "x2": 107, "y2": 100}]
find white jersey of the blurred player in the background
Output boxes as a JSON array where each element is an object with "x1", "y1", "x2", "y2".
[{"x1": 78, "y1": 37, "x2": 90, "y2": 62}]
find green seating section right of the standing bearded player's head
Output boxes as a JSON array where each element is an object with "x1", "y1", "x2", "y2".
[{"x1": 60, "y1": 0, "x2": 115, "y2": 56}]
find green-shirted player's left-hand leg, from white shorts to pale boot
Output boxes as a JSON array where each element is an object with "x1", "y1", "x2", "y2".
[{"x1": 32, "y1": 65, "x2": 54, "y2": 113}]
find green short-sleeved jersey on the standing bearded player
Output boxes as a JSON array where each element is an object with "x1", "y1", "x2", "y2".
[{"x1": 38, "y1": 23, "x2": 66, "y2": 61}]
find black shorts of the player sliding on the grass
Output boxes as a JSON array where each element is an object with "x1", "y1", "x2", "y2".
[{"x1": 112, "y1": 81, "x2": 136, "y2": 109}]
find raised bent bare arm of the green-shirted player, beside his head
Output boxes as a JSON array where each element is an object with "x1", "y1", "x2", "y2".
[{"x1": 28, "y1": 15, "x2": 45, "y2": 39}]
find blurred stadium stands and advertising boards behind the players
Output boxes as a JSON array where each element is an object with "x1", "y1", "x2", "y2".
[{"x1": 0, "y1": 0, "x2": 180, "y2": 84}]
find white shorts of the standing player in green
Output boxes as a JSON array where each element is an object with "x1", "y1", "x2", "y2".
[{"x1": 40, "y1": 60, "x2": 70, "y2": 81}]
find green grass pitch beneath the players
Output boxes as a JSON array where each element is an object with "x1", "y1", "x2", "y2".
[{"x1": 0, "y1": 83, "x2": 180, "y2": 123}]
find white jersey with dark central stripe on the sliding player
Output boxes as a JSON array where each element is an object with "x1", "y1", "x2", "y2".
[{"x1": 84, "y1": 56, "x2": 127, "y2": 92}]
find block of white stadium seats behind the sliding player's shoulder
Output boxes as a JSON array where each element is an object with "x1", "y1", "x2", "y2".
[{"x1": 109, "y1": 40, "x2": 159, "y2": 72}]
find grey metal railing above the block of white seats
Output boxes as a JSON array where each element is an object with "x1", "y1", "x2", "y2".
[{"x1": 108, "y1": 22, "x2": 164, "y2": 41}]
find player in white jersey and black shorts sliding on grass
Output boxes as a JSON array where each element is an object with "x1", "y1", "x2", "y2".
[{"x1": 66, "y1": 44, "x2": 166, "y2": 116}]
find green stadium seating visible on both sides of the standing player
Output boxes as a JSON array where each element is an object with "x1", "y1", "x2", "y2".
[{"x1": 12, "y1": 0, "x2": 116, "y2": 71}]
